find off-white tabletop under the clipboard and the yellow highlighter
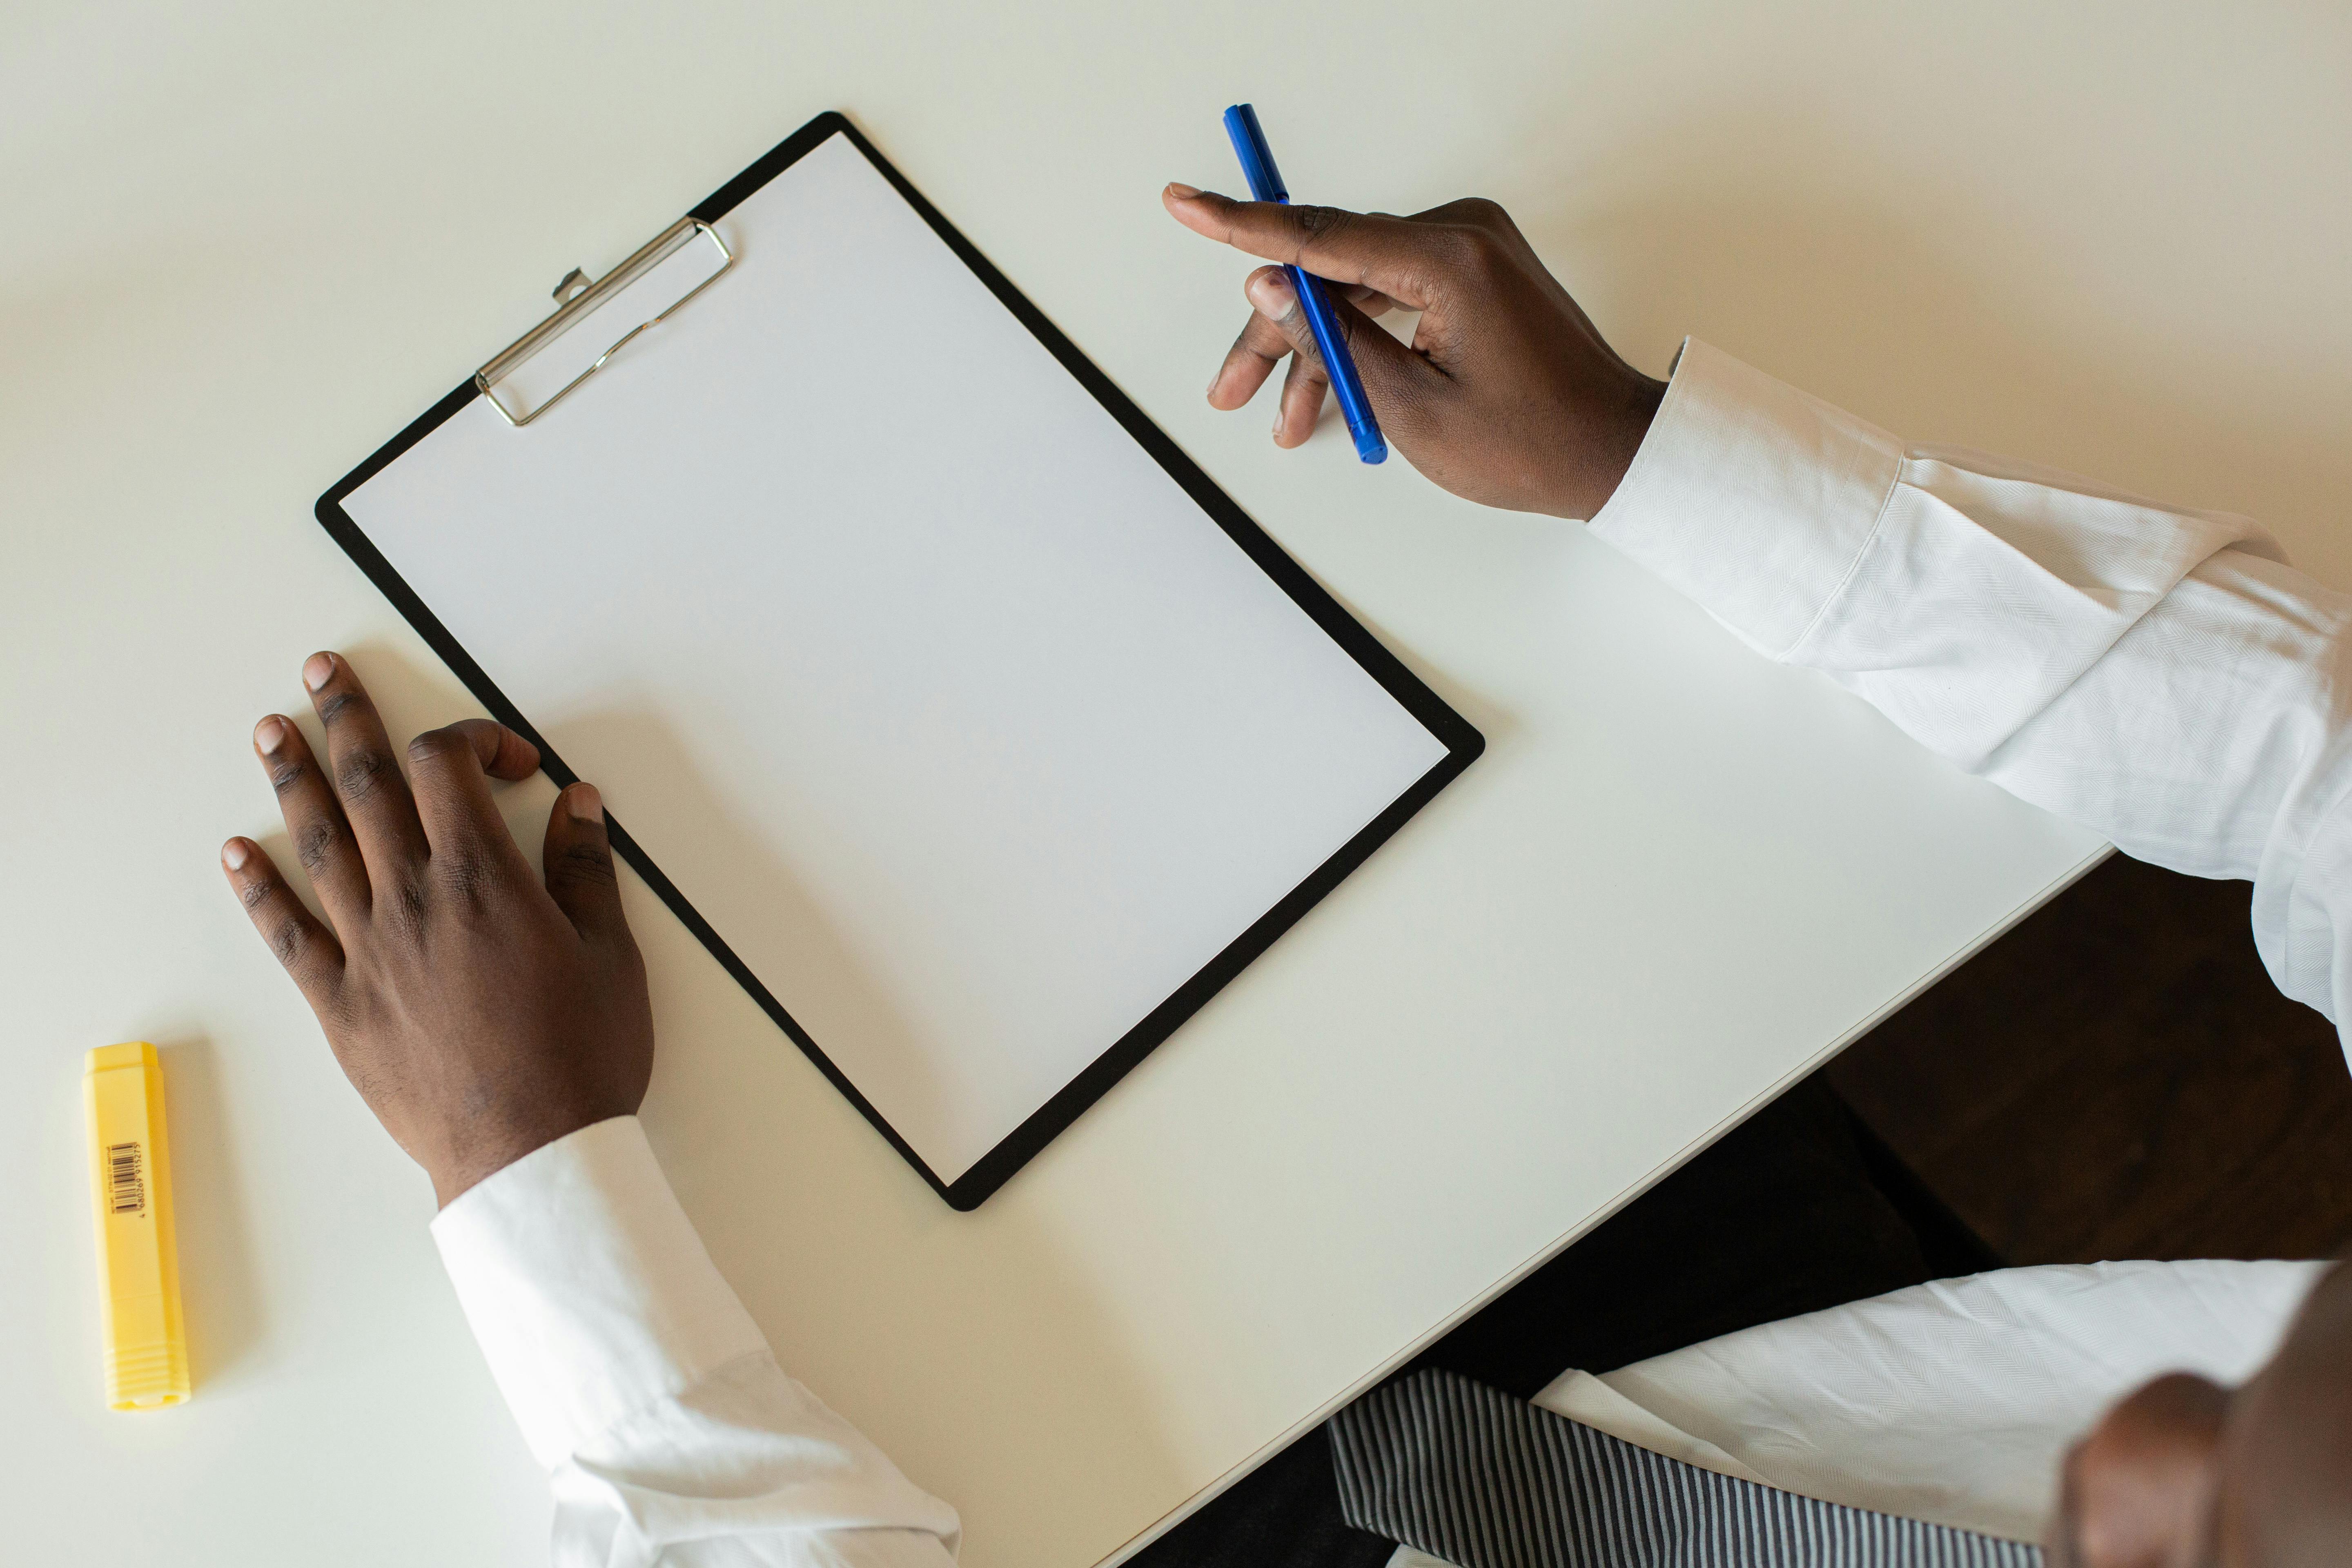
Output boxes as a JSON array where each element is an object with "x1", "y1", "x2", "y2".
[{"x1": 0, "y1": 0, "x2": 2352, "y2": 1568}]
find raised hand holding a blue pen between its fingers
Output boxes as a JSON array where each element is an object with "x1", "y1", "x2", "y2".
[{"x1": 1162, "y1": 186, "x2": 1665, "y2": 517}]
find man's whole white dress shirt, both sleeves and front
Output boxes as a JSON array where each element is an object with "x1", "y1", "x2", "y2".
[{"x1": 433, "y1": 341, "x2": 2352, "y2": 1568}]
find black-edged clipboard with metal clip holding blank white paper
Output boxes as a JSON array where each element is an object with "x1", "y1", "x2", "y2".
[{"x1": 318, "y1": 113, "x2": 1484, "y2": 1211}]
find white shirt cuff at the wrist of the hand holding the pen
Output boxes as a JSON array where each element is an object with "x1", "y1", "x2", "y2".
[{"x1": 1592, "y1": 339, "x2": 1903, "y2": 658}]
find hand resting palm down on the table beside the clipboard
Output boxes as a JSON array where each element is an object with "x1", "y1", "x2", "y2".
[{"x1": 221, "y1": 653, "x2": 654, "y2": 1204}]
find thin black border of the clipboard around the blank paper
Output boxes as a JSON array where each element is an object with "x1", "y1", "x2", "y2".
[{"x1": 318, "y1": 111, "x2": 1486, "y2": 1211}]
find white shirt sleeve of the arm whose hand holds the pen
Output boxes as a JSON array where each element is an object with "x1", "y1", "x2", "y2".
[{"x1": 1592, "y1": 341, "x2": 2352, "y2": 1025}]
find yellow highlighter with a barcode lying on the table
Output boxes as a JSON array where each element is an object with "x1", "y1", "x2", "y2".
[{"x1": 82, "y1": 1041, "x2": 188, "y2": 1410}]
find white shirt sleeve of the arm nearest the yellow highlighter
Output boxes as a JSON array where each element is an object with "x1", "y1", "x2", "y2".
[{"x1": 433, "y1": 1117, "x2": 957, "y2": 1568}]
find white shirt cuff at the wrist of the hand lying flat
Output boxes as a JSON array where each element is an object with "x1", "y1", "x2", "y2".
[{"x1": 433, "y1": 1117, "x2": 767, "y2": 1469}]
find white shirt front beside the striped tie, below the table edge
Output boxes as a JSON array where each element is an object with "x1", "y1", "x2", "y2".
[{"x1": 1536, "y1": 1263, "x2": 2326, "y2": 1540}]
